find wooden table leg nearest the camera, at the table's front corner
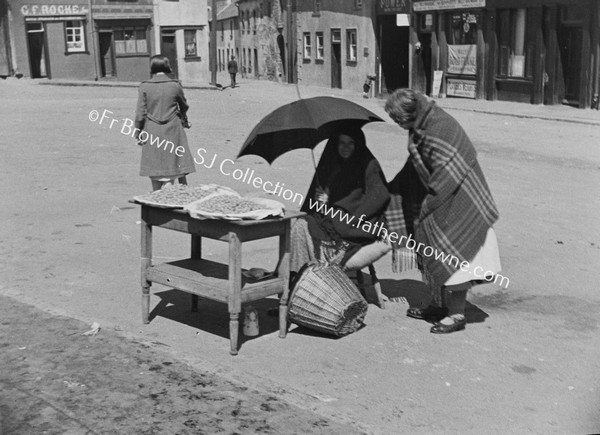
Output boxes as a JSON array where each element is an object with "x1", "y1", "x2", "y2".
[{"x1": 228, "y1": 232, "x2": 242, "y2": 355}]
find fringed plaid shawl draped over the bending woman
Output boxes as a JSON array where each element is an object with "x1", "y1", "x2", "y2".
[{"x1": 386, "y1": 96, "x2": 499, "y2": 287}]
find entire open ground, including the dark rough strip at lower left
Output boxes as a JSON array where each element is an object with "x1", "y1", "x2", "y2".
[{"x1": 0, "y1": 79, "x2": 600, "y2": 435}]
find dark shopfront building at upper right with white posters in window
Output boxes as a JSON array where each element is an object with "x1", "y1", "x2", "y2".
[{"x1": 410, "y1": 0, "x2": 600, "y2": 108}]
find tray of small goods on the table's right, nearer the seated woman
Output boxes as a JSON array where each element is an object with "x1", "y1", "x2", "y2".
[{"x1": 184, "y1": 191, "x2": 284, "y2": 220}]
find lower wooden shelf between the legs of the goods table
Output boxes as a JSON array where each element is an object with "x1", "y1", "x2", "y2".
[{"x1": 146, "y1": 258, "x2": 288, "y2": 303}]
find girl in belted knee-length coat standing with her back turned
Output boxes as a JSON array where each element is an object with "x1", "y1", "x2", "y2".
[{"x1": 135, "y1": 54, "x2": 196, "y2": 190}]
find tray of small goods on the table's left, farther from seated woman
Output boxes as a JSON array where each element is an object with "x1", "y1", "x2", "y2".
[{"x1": 133, "y1": 184, "x2": 235, "y2": 208}]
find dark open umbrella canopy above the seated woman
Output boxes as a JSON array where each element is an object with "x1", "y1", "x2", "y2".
[{"x1": 238, "y1": 97, "x2": 384, "y2": 163}]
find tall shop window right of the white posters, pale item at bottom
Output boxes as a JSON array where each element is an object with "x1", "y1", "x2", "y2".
[{"x1": 498, "y1": 8, "x2": 535, "y2": 79}]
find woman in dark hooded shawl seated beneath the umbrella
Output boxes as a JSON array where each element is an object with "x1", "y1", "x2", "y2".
[{"x1": 291, "y1": 126, "x2": 391, "y2": 272}]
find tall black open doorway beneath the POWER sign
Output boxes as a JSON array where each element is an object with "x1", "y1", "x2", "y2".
[{"x1": 378, "y1": 15, "x2": 409, "y2": 93}]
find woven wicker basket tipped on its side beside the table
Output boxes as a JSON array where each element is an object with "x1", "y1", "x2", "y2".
[{"x1": 288, "y1": 262, "x2": 368, "y2": 337}]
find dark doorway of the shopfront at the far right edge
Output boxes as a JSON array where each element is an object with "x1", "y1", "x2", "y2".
[{"x1": 558, "y1": 26, "x2": 583, "y2": 106}]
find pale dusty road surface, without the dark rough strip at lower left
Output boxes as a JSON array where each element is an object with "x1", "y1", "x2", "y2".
[{"x1": 0, "y1": 81, "x2": 600, "y2": 434}]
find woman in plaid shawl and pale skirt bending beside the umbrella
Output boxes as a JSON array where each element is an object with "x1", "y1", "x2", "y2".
[{"x1": 385, "y1": 89, "x2": 500, "y2": 334}]
